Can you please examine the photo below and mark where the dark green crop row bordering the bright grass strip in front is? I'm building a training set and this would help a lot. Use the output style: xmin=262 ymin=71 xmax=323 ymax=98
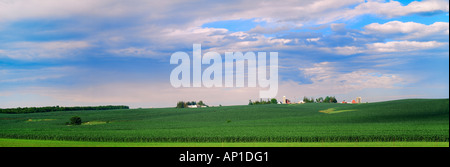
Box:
xmin=0 ymin=134 xmax=449 ymax=142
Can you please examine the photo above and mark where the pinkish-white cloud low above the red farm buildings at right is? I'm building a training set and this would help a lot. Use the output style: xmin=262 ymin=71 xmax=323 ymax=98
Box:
xmin=290 ymin=62 xmax=407 ymax=96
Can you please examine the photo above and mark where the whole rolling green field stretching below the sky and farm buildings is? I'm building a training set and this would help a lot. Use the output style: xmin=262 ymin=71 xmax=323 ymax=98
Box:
xmin=0 ymin=99 xmax=449 ymax=147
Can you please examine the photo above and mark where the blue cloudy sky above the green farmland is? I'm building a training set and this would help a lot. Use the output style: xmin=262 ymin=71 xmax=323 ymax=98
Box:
xmin=0 ymin=0 xmax=449 ymax=108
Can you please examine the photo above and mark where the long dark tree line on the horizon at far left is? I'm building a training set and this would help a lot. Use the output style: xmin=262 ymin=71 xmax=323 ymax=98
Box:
xmin=0 ymin=105 xmax=130 ymax=114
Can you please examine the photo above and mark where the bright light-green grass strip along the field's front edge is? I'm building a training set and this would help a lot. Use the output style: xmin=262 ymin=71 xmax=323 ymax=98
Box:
xmin=0 ymin=139 xmax=449 ymax=147
